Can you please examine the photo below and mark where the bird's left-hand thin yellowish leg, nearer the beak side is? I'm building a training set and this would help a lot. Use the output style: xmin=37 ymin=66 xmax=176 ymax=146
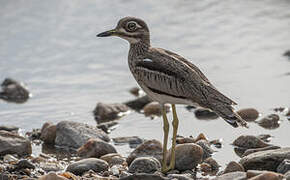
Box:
xmin=161 ymin=104 xmax=169 ymax=172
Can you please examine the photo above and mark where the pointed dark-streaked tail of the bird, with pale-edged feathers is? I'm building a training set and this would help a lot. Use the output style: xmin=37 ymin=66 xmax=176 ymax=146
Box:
xmin=212 ymin=105 xmax=249 ymax=128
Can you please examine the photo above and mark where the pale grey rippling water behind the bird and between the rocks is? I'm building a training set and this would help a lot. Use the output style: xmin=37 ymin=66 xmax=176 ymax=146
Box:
xmin=0 ymin=0 xmax=290 ymax=169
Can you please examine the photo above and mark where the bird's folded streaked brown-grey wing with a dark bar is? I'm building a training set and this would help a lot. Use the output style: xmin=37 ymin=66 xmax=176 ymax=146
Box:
xmin=135 ymin=48 xmax=234 ymax=105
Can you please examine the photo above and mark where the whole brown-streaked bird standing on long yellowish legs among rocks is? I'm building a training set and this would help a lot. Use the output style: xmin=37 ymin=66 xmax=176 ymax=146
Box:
xmin=97 ymin=16 xmax=248 ymax=172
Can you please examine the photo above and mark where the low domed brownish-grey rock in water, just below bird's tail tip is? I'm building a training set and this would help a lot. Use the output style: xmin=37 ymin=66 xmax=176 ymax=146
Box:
xmin=233 ymin=135 xmax=269 ymax=149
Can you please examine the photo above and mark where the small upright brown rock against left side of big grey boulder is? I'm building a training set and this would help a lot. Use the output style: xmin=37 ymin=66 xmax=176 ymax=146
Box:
xmin=40 ymin=122 xmax=56 ymax=144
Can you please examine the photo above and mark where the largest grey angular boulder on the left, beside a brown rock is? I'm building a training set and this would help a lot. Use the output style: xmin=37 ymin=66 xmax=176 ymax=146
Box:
xmin=55 ymin=121 xmax=110 ymax=149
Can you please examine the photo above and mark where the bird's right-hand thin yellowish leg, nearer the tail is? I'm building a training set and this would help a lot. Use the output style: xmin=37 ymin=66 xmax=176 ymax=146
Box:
xmin=169 ymin=104 xmax=179 ymax=169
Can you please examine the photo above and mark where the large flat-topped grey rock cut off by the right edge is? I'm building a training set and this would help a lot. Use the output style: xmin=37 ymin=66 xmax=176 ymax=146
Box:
xmin=240 ymin=147 xmax=290 ymax=171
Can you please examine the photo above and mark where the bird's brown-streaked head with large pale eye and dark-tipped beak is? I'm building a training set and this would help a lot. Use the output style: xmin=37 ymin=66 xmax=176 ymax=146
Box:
xmin=97 ymin=17 xmax=150 ymax=45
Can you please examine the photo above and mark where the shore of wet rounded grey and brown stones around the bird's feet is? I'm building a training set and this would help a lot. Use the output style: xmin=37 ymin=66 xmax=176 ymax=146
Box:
xmin=0 ymin=84 xmax=290 ymax=180
